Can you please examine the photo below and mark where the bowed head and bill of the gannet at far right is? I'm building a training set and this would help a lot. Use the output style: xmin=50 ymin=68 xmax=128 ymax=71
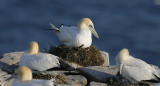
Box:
xmin=116 ymin=48 xmax=129 ymax=74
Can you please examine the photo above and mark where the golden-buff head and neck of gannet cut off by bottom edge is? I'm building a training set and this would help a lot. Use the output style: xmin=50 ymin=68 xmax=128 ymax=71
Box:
xmin=15 ymin=66 xmax=32 ymax=81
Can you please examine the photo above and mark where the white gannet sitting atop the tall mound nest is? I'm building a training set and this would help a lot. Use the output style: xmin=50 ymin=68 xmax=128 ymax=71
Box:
xmin=50 ymin=18 xmax=99 ymax=48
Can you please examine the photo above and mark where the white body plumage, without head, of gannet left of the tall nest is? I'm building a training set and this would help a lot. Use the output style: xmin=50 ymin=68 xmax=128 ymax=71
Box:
xmin=19 ymin=53 xmax=59 ymax=71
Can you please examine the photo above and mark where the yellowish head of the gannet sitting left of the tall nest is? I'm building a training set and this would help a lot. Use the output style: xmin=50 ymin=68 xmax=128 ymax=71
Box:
xmin=28 ymin=41 xmax=39 ymax=55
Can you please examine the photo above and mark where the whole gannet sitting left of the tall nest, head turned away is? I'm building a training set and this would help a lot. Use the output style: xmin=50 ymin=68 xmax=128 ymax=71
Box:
xmin=19 ymin=42 xmax=59 ymax=71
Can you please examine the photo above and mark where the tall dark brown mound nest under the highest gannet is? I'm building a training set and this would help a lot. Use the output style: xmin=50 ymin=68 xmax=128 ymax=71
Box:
xmin=49 ymin=45 xmax=104 ymax=67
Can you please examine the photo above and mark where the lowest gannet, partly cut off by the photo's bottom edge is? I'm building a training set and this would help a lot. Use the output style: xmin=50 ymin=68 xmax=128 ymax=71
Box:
xmin=9 ymin=66 xmax=54 ymax=86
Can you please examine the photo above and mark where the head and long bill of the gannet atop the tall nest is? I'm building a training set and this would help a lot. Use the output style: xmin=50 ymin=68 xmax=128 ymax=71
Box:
xmin=77 ymin=18 xmax=99 ymax=39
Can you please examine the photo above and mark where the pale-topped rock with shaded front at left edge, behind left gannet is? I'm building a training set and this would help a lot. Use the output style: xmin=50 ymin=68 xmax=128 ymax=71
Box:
xmin=0 ymin=52 xmax=23 ymax=73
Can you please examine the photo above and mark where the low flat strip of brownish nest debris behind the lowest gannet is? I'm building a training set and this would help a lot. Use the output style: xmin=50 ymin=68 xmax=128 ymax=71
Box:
xmin=33 ymin=73 xmax=67 ymax=84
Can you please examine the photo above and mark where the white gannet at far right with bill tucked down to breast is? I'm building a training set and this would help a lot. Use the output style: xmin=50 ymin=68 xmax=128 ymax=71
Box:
xmin=115 ymin=49 xmax=160 ymax=83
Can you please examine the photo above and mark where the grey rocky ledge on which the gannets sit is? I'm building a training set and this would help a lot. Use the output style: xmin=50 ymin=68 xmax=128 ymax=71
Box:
xmin=0 ymin=51 xmax=157 ymax=86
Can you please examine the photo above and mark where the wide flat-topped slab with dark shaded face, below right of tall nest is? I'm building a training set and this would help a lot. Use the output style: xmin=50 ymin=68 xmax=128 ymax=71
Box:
xmin=78 ymin=66 xmax=118 ymax=82
